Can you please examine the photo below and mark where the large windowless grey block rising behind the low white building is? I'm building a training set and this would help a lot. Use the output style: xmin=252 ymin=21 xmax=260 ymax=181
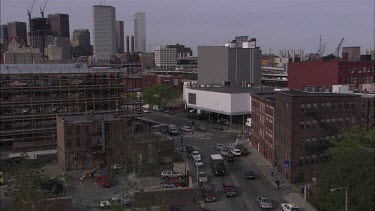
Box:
xmin=198 ymin=46 xmax=262 ymax=86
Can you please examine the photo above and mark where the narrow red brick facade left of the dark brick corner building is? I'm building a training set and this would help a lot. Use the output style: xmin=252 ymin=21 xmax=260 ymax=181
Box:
xmin=251 ymin=93 xmax=275 ymax=163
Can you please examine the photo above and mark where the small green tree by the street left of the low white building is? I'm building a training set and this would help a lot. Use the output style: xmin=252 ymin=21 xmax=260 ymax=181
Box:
xmin=142 ymin=85 xmax=180 ymax=108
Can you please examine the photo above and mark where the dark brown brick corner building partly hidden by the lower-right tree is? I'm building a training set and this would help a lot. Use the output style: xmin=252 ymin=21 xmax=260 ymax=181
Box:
xmin=274 ymin=91 xmax=361 ymax=183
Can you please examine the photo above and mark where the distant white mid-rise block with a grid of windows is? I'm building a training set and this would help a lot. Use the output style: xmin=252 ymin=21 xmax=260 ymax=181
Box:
xmin=154 ymin=46 xmax=177 ymax=69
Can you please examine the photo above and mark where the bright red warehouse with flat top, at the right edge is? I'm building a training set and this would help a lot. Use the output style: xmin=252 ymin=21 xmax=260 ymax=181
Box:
xmin=288 ymin=61 xmax=375 ymax=90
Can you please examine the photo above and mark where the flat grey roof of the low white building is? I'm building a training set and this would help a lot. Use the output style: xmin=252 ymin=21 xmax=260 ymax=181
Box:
xmin=189 ymin=86 xmax=273 ymax=94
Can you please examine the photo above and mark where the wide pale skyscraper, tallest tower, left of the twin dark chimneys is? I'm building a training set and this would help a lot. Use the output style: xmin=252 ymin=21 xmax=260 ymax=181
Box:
xmin=92 ymin=5 xmax=116 ymax=60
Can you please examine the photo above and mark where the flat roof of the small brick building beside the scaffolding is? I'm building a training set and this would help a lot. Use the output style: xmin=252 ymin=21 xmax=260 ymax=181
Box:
xmin=61 ymin=113 xmax=120 ymax=124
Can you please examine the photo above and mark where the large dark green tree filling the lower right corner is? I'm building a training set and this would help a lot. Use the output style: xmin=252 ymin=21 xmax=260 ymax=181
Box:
xmin=313 ymin=128 xmax=375 ymax=211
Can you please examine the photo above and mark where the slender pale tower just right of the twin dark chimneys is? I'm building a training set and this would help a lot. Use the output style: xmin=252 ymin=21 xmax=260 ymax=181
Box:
xmin=134 ymin=12 xmax=146 ymax=53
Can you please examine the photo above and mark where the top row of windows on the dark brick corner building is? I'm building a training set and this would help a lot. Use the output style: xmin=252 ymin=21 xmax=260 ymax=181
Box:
xmin=300 ymin=101 xmax=357 ymax=112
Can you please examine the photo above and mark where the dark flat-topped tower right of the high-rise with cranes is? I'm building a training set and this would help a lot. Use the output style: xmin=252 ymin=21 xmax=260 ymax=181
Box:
xmin=48 ymin=13 xmax=70 ymax=38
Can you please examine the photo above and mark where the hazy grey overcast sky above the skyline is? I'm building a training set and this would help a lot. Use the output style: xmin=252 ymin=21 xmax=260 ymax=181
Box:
xmin=0 ymin=0 xmax=375 ymax=54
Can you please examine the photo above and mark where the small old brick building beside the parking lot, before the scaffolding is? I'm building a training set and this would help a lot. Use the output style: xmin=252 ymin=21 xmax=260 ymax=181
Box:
xmin=56 ymin=113 xmax=122 ymax=171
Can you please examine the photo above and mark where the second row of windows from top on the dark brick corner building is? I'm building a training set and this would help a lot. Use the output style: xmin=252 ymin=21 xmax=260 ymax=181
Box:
xmin=300 ymin=117 xmax=356 ymax=129
